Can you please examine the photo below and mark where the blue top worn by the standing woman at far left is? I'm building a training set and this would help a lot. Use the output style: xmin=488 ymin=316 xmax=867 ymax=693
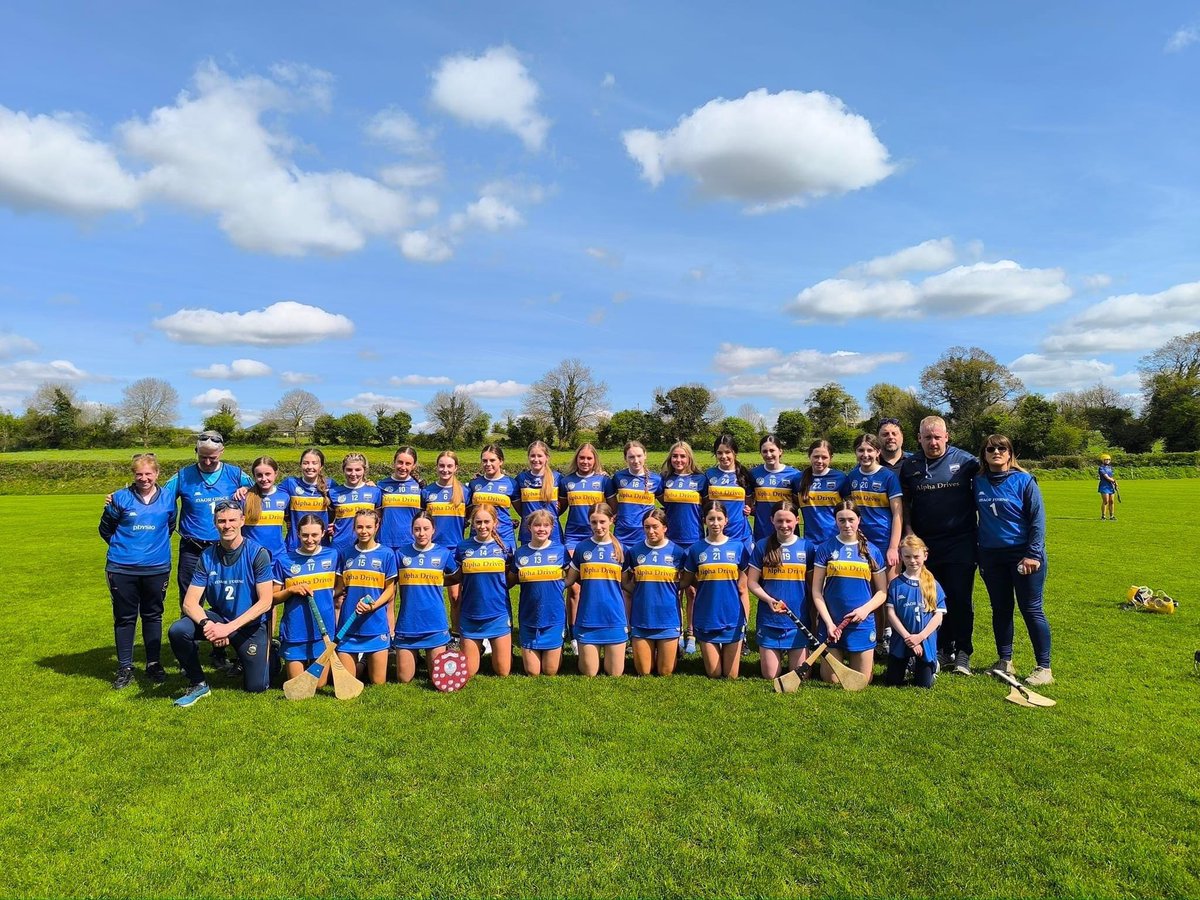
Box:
xmin=100 ymin=487 xmax=175 ymax=575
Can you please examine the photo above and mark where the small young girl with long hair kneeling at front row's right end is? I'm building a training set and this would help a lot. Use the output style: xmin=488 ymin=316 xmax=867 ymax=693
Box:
xmin=883 ymin=534 xmax=946 ymax=688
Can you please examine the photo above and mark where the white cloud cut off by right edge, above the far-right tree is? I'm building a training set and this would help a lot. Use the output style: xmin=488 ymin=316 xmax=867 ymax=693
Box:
xmin=1042 ymin=281 xmax=1200 ymax=355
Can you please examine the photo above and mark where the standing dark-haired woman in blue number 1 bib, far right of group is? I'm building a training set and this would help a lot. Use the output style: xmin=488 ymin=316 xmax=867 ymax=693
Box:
xmin=974 ymin=434 xmax=1054 ymax=685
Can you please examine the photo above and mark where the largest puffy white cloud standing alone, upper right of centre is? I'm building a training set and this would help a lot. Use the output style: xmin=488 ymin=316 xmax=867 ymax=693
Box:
xmin=622 ymin=89 xmax=893 ymax=212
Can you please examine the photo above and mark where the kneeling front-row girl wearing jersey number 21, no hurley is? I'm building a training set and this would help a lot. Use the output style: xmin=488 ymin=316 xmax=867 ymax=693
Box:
xmin=682 ymin=500 xmax=750 ymax=678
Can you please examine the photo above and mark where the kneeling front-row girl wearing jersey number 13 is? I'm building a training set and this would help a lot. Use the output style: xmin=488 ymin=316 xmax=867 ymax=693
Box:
xmin=509 ymin=509 xmax=568 ymax=676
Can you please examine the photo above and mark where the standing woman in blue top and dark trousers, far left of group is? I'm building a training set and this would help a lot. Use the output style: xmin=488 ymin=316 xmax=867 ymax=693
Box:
xmin=100 ymin=454 xmax=175 ymax=690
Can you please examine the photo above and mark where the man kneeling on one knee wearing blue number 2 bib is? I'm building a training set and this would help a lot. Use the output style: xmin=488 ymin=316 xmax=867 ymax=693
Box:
xmin=167 ymin=500 xmax=272 ymax=707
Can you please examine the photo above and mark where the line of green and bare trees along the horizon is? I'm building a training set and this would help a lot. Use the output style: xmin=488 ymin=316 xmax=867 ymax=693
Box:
xmin=0 ymin=331 xmax=1200 ymax=458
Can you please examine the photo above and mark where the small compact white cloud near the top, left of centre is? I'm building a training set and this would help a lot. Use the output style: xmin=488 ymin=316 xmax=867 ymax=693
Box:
xmin=431 ymin=46 xmax=550 ymax=150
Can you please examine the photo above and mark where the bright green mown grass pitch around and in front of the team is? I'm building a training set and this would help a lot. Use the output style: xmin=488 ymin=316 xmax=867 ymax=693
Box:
xmin=0 ymin=480 xmax=1200 ymax=896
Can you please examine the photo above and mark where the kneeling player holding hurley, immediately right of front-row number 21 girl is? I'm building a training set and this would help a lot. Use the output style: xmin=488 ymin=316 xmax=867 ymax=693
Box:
xmin=748 ymin=500 xmax=814 ymax=678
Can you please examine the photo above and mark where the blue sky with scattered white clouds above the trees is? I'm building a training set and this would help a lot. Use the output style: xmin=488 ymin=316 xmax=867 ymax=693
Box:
xmin=0 ymin=2 xmax=1200 ymax=434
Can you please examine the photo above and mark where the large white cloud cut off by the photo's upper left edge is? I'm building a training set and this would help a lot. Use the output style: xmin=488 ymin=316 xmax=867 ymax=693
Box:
xmin=0 ymin=106 xmax=142 ymax=216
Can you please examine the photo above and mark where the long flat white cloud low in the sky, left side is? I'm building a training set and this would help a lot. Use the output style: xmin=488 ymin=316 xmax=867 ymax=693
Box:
xmin=154 ymin=300 xmax=354 ymax=347
